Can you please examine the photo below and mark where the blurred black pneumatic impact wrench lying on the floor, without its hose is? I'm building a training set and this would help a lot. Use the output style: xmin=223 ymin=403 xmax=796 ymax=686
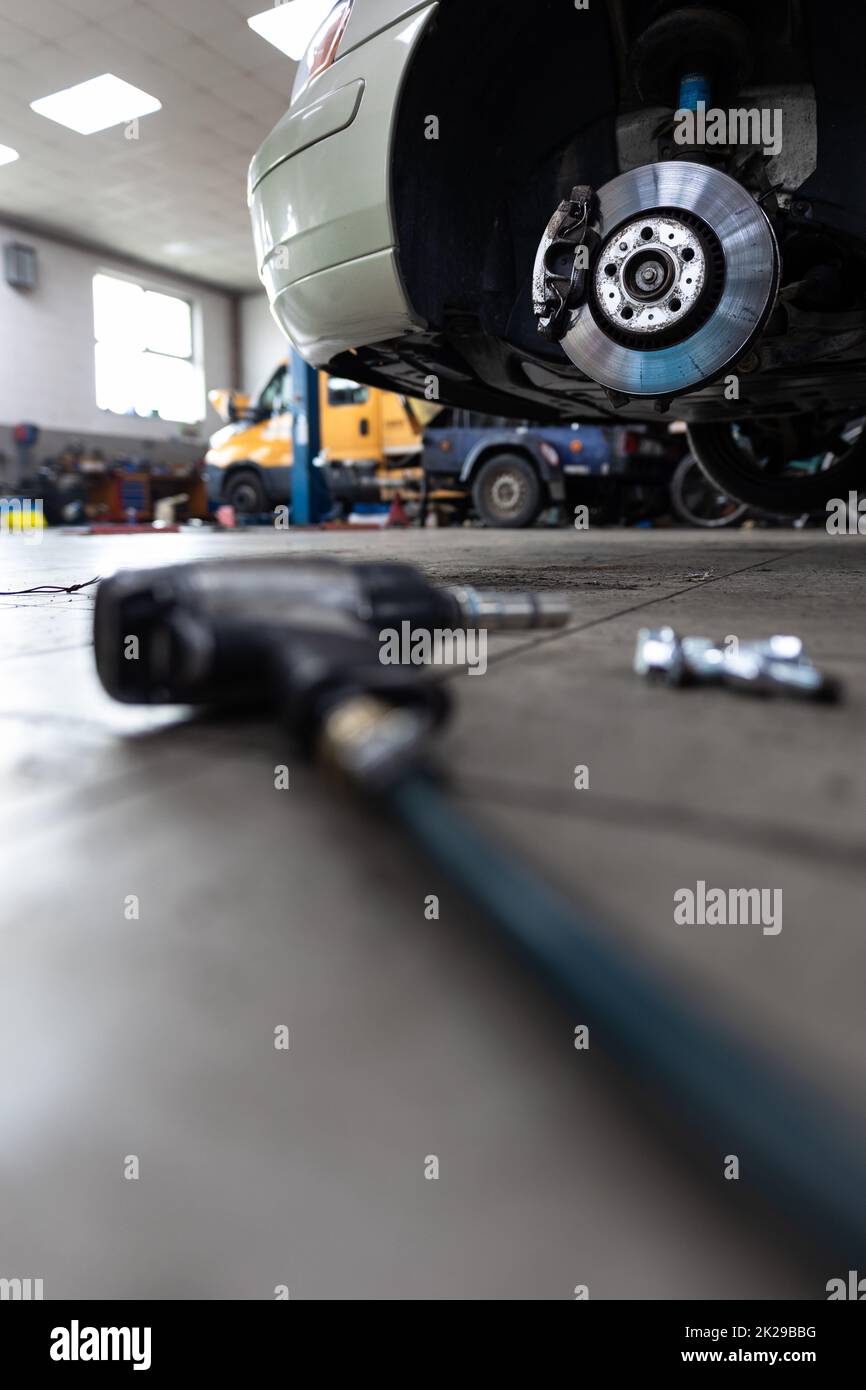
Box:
xmin=95 ymin=556 xmax=569 ymax=787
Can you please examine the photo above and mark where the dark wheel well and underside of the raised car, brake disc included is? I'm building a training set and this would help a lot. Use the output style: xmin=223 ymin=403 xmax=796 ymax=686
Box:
xmin=331 ymin=0 xmax=866 ymax=512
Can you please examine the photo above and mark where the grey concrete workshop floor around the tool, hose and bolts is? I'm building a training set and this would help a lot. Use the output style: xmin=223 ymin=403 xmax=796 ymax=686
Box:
xmin=0 ymin=530 xmax=866 ymax=1298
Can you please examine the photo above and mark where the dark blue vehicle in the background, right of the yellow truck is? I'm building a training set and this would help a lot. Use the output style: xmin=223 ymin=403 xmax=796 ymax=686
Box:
xmin=421 ymin=410 xmax=685 ymax=527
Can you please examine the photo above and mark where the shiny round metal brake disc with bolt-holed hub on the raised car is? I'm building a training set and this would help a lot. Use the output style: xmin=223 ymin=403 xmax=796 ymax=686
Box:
xmin=562 ymin=161 xmax=778 ymax=396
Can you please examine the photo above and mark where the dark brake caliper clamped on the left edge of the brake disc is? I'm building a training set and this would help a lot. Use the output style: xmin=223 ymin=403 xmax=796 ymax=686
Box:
xmin=532 ymin=183 xmax=598 ymax=342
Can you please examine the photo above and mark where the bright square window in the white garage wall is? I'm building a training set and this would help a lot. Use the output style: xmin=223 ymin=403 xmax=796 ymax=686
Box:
xmin=93 ymin=274 xmax=204 ymax=424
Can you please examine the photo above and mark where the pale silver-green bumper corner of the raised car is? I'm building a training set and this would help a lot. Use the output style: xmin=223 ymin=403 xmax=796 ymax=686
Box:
xmin=249 ymin=0 xmax=436 ymax=366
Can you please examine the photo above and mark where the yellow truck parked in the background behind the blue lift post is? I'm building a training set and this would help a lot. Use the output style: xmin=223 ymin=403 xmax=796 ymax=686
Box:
xmin=204 ymin=361 xmax=423 ymax=516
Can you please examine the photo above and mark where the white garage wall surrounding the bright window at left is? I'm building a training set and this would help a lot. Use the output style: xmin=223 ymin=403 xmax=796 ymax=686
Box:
xmin=0 ymin=222 xmax=235 ymax=441
